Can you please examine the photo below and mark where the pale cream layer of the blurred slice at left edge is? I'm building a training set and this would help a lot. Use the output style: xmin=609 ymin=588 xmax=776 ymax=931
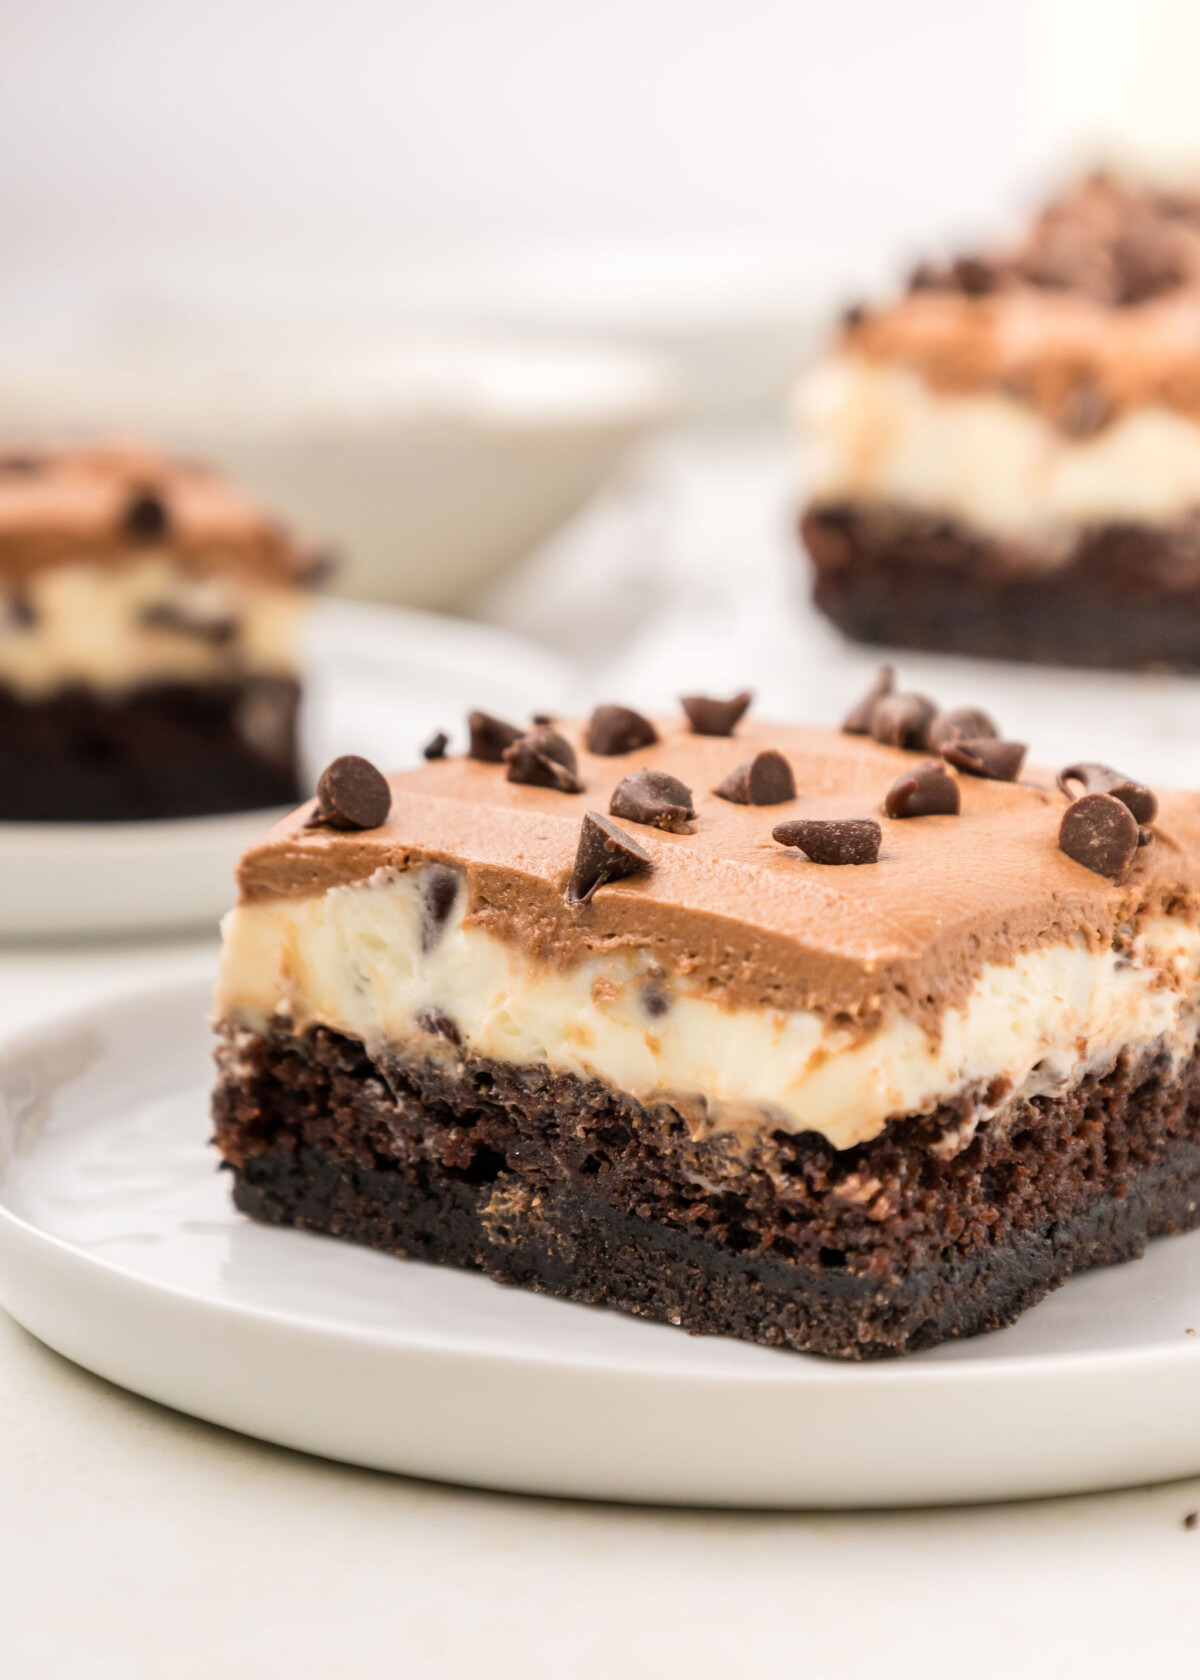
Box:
xmin=0 ymin=554 xmax=304 ymax=699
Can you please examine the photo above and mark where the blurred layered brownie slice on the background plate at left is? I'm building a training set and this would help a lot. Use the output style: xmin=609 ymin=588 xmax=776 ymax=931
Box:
xmin=0 ymin=445 xmax=316 ymax=822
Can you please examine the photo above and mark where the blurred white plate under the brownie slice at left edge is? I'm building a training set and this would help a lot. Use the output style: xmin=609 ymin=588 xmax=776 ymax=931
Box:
xmin=0 ymin=601 xmax=568 ymax=937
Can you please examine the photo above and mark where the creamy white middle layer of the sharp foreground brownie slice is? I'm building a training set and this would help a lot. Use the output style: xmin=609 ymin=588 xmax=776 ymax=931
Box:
xmin=217 ymin=870 xmax=1200 ymax=1149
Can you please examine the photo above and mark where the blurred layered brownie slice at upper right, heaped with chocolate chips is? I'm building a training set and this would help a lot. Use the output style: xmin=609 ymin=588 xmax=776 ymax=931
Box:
xmin=797 ymin=176 xmax=1200 ymax=669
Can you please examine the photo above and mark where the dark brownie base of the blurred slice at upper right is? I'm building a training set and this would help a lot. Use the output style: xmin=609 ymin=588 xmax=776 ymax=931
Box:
xmin=800 ymin=504 xmax=1200 ymax=670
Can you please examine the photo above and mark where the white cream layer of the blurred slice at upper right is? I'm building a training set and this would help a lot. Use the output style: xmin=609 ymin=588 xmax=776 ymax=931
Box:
xmin=795 ymin=356 xmax=1200 ymax=559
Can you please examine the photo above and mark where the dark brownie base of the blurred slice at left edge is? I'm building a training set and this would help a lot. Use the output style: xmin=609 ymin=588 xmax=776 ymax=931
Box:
xmin=0 ymin=679 xmax=303 ymax=823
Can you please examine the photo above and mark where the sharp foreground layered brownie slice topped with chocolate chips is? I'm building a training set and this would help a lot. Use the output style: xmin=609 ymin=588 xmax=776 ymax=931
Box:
xmin=215 ymin=688 xmax=1200 ymax=1359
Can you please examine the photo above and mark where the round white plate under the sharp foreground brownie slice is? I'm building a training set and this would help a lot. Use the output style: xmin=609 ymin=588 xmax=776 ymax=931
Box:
xmin=0 ymin=983 xmax=1200 ymax=1505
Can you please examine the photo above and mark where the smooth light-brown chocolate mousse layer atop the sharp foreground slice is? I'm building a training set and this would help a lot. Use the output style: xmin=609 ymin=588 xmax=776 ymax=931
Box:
xmin=231 ymin=716 xmax=1200 ymax=1032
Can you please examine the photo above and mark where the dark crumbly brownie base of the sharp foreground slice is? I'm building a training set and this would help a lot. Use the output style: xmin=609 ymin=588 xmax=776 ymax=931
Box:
xmin=213 ymin=1028 xmax=1200 ymax=1359
